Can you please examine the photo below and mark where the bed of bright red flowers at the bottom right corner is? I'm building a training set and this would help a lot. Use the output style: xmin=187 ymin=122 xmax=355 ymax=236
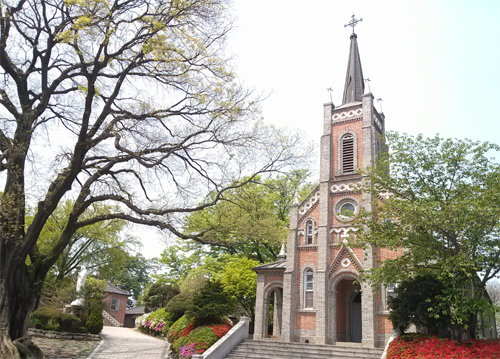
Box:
xmin=387 ymin=335 xmax=500 ymax=359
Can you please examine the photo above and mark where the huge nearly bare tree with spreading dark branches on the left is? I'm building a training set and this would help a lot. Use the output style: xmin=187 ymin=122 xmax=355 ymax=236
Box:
xmin=0 ymin=0 xmax=295 ymax=358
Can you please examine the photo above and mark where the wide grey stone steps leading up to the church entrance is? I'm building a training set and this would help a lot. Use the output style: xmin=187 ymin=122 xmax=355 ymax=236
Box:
xmin=226 ymin=339 xmax=384 ymax=359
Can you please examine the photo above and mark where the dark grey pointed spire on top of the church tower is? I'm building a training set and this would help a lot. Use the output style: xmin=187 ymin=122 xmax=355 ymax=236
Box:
xmin=342 ymin=33 xmax=365 ymax=105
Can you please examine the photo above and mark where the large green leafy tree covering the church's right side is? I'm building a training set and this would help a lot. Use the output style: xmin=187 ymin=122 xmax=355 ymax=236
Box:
xmin=358 ymin=133 xmax=500 ymax=339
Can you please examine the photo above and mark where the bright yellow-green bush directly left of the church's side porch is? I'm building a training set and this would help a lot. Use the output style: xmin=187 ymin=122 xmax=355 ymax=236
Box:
xmin=218 ymin=257 xmax=259 ymax=322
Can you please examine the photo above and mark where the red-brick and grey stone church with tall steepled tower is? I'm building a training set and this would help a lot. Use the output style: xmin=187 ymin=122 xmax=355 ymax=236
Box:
xmin=254 ymin=23 xmax=395 ymax=347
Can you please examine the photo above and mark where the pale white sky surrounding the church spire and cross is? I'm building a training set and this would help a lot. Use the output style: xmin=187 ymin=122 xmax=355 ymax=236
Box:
xmin=143 ymin=0 xmax=500 ymax=257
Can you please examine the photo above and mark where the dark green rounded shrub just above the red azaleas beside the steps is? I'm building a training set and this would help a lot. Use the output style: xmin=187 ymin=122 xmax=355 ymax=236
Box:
xmin=187 ymin=280 xmax=235 ymax=325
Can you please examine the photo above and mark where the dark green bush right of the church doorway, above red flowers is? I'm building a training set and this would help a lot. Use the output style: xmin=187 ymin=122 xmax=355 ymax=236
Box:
xmin=389 ymin=276 xmax=450 ymax=335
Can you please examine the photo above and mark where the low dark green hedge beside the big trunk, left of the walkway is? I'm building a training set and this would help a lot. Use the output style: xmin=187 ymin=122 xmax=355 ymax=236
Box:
xmin=29 ymin=307 xmax=85 ymax=333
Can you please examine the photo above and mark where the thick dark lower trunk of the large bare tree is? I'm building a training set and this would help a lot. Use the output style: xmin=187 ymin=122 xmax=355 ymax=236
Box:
xmin=0 ymin=248 xmax=43 ymax=359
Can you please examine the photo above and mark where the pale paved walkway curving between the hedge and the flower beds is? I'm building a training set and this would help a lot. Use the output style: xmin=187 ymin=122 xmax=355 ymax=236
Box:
xmin=89 ymin=326 xmax=168 ymax=359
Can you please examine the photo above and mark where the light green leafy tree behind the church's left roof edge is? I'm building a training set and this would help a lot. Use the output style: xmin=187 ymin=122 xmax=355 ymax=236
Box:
xmin=185 ymin=170 xmax=312 ymax=263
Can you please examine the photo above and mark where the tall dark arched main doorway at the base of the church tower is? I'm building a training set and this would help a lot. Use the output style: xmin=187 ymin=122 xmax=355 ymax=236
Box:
xmin=335 ymin=278 xmax=362 ymax=343
